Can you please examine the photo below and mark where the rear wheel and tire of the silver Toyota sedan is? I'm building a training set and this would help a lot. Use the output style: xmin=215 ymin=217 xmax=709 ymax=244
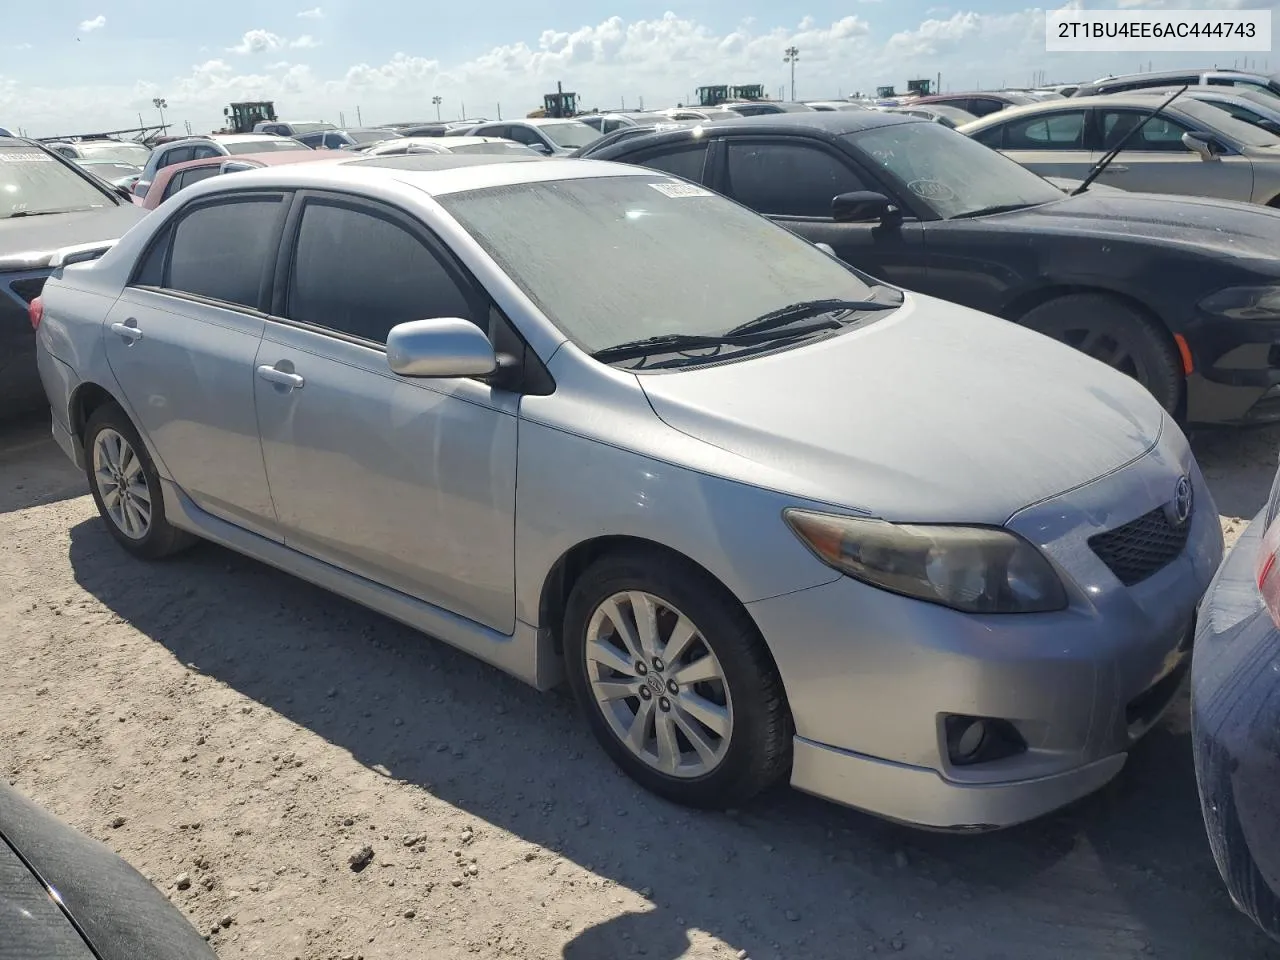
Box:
xmin=84 ymin=403 xmax=196 ymax=559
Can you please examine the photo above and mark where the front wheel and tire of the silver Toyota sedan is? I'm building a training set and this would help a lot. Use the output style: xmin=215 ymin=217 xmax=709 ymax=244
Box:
xmin=564 ymin=550 xmax=791 ymax=809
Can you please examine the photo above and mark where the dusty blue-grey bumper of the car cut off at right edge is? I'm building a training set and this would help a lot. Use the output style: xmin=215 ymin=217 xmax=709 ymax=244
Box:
xmin=1192 ymin=511 xmax=1280 ymax=940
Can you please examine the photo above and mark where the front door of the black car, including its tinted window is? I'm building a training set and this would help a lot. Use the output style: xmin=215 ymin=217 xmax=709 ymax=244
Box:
xmin=713 ymin=137 xmax=925 ymax=289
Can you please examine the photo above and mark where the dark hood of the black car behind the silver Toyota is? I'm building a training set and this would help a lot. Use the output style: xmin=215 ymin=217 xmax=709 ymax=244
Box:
xmin=984 ymin=187 xmax=1280 ymax=259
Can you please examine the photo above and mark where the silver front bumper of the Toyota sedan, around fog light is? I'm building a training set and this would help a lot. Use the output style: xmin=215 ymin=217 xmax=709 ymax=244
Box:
xmin=748 ymin=426 xmax=1222 ymax=829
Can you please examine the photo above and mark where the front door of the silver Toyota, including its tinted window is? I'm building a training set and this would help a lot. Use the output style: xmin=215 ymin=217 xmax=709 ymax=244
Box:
xmin=253 ymin=193 xmax=520 ymax=634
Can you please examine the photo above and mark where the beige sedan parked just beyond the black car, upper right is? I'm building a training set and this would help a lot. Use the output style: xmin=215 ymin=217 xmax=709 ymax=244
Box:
xmin=959 ymin=93 xmax=1280 ymax=206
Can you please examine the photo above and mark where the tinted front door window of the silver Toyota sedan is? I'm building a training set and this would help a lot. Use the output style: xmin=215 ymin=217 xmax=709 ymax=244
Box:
xmin=287 ymin=201 xmax=471 ymax=343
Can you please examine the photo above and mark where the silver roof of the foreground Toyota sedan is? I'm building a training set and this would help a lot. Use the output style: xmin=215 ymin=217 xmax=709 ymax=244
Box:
xmin=183 ymin=154 xmax=667 ymax=204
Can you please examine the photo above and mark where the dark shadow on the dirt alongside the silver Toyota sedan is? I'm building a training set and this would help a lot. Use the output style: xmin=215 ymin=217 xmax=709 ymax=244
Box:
xmin=70 ymin=520 xmax=1271 ymax=960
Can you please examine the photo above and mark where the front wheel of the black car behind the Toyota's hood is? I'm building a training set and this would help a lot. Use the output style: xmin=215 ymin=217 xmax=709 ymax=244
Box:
xmin=1018 ymin=293 xmax=1184 ymax=413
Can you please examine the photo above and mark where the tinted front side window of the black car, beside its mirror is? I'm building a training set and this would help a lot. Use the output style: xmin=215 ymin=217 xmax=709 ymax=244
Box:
xmin=727 ymin=140 xmax=865 ymax=216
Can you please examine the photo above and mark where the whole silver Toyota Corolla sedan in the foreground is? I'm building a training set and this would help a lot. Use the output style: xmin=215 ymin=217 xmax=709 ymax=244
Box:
xmin=32 ymin=155 xmax=1222 ymax=829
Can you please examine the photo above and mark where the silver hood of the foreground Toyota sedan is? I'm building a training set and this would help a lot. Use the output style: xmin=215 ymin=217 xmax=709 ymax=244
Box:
xmin=637 ymin=294 xmax=1165 ymax=524
